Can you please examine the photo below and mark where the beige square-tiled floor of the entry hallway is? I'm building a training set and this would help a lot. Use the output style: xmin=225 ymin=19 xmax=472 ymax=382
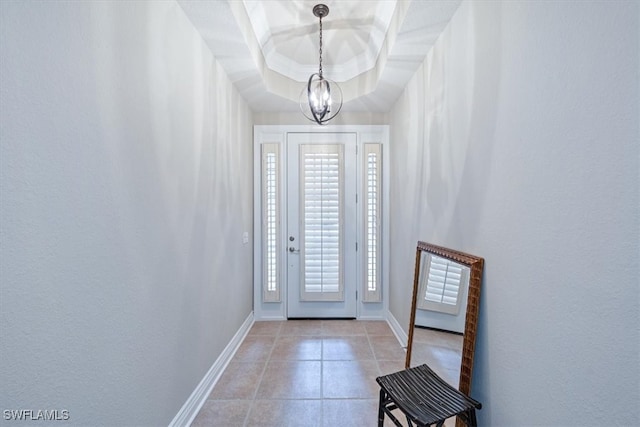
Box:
xmin=192 ymin=320 xmax=459 ymax=427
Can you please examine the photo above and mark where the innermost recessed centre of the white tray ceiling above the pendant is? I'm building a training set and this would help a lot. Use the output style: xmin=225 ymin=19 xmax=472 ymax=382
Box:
xmin=243 ymin=0 xmax=396 ymax=83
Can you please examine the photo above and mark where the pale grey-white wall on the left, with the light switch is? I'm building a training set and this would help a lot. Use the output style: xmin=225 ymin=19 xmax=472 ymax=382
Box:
xmin=0 ymin=1 xmax=253 ymax=426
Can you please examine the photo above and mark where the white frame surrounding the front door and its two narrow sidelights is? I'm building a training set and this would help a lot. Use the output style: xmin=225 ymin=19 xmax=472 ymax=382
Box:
xmin=253 ymin=125 xmax=390 ymax=320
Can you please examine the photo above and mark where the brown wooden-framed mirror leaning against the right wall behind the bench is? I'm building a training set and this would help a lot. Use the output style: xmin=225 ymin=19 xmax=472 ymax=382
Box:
xmin=405 ymin=242 xmax=484 ymax=395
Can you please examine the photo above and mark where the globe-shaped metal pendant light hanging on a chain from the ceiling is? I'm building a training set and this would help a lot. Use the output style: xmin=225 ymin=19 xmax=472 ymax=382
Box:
xmin=300 ymin=4 xmax=342 ymax=125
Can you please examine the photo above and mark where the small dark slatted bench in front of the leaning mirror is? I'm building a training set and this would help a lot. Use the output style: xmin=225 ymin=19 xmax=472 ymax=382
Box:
xmin=376 ymin=365 xmax=482 ymax=427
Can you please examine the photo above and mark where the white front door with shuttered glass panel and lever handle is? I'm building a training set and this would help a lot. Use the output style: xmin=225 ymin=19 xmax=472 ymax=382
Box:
xmin=286 ymin=133 xmax=358 ymax=318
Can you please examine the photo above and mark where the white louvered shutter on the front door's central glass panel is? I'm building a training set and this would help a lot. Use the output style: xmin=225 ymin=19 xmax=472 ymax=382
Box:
xmin=299 ymin=144 xmax=344 ymax=301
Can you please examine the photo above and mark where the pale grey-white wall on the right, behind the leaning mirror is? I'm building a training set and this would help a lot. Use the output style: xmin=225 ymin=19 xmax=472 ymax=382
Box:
xmin=390 ymin=1 xmax=640 ymax=426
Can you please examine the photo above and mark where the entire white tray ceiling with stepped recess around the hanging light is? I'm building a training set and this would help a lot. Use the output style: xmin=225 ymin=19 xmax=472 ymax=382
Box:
xmin=178 ymin=0 xmax=461 ymax=112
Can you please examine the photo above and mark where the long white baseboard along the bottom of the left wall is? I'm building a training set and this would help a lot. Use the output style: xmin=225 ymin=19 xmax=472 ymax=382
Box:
xmin=169 ymin=312 xmax=254 ymax=427
